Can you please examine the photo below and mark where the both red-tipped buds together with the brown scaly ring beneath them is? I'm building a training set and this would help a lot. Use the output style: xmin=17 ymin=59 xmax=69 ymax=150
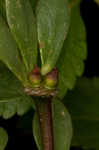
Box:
xmin=25 ymin=65 xmax=58 ymax=96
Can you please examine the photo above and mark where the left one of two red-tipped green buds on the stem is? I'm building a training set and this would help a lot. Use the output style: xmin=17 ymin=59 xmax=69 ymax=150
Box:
xmin=28 ymin=65 xmax=41 ymax=87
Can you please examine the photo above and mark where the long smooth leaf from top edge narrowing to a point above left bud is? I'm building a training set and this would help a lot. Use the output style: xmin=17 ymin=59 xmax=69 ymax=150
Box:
xmin=6 ymin=0 xmax=37 ymax=72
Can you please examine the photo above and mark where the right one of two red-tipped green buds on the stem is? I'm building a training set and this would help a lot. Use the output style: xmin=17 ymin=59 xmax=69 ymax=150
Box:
xmin=44 ymin=68 xmax=58 ymax=89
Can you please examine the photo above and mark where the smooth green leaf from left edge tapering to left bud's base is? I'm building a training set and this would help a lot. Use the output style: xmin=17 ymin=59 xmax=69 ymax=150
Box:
xmin=0 ymin=16 xmax=27 ymax=84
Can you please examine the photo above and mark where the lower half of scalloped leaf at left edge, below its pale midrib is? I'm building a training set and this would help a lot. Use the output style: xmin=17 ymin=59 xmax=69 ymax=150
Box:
xmin=0 ymin=96 xmax=35 ymax=119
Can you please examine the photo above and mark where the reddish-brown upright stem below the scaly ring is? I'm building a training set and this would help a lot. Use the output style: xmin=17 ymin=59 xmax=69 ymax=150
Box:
xmin=37 ymin=98 xmax=54 ymax=150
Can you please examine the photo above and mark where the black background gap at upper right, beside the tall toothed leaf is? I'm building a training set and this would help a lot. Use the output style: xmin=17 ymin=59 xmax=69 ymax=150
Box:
xmin=81 ymin=0 xmax=99 ymax=77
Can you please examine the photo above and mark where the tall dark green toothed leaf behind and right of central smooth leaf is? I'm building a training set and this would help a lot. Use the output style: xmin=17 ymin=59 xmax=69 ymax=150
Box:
xmin=57 ymin=5 xmax=86 ymax=99
